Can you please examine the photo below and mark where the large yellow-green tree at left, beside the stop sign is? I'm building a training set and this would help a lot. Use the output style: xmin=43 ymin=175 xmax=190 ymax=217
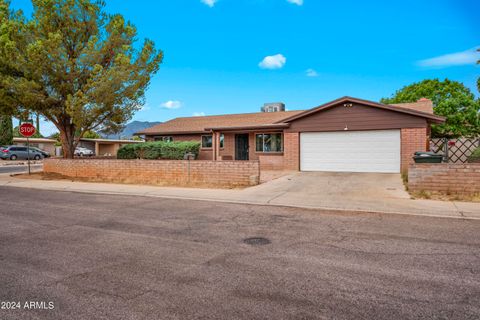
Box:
xmin=0 ymin=0 xmax=163 ymax=158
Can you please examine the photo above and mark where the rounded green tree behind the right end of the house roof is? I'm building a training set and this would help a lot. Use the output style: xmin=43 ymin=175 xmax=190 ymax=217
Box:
xmin=381 ymin=79 xmax=480 ymax=138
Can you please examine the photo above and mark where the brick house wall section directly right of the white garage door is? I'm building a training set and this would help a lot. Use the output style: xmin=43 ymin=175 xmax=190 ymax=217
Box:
xmin=401 ymin=128 xmax=428 ymax=173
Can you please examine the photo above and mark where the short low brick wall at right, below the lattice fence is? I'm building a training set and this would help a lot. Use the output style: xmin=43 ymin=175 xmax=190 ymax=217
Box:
xmin=408 ymin=163 xmax=480 ymax=195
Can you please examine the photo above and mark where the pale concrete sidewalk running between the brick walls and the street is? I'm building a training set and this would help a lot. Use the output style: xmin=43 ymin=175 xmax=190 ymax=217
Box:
xmin=0 ymin=174 xmax=480 ymax=220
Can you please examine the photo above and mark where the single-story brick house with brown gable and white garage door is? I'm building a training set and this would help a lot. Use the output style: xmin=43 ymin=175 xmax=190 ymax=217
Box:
xmin=137 ymin=97 xmax=445 ymax=173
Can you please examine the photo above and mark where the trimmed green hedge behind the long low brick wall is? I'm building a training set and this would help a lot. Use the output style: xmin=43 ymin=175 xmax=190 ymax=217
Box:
xmin=117 ymin=141 xmax=200 ymax=160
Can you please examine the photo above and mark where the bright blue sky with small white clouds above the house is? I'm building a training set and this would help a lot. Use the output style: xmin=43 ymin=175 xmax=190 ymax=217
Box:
xmin=12 ymin=0 xmax=480 ymax=134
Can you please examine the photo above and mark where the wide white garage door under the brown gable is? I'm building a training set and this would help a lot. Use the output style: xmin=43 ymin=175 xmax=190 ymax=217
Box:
xmin=300 ymin=130 xmax=400 ymax=173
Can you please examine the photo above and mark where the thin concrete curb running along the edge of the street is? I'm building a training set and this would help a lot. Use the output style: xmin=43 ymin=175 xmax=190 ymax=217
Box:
xmin=0 ymin=181 xmax=480 ymax=220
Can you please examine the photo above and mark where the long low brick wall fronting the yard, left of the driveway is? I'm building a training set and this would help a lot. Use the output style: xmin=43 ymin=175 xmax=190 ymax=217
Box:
xmin=43 ymin=159 xmax=260 ymax=188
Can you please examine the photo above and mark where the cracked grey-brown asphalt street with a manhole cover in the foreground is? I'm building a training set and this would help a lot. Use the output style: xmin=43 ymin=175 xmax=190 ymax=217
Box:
xmin=0 ymin=187 xmax=480 ymax=320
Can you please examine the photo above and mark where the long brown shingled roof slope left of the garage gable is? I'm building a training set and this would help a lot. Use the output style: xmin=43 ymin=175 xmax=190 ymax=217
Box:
xmin=136 ymin=110 xmax=303 ymax=135
